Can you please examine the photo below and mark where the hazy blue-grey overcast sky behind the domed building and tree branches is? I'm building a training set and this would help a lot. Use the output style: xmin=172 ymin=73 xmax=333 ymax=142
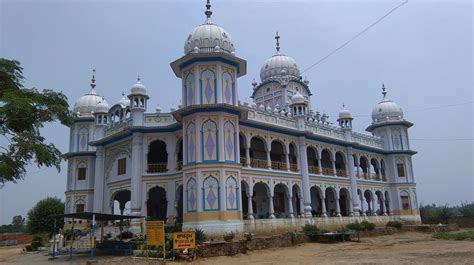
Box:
xmin=0 ymin=0 xmax=474 ymax=223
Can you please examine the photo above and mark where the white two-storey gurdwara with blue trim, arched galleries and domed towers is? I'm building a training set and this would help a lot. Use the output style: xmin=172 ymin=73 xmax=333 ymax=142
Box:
xmin=65 ymin=2 xmax=420 ymax=233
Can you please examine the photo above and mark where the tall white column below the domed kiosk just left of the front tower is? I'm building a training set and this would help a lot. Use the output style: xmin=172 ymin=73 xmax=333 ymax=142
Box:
xmin=130 ymin=133 xmax=143 ymax=215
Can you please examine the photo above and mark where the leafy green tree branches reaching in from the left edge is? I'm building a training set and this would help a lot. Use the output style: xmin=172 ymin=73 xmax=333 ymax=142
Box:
xmin=0 ymin=58 xmax=73 ymax=183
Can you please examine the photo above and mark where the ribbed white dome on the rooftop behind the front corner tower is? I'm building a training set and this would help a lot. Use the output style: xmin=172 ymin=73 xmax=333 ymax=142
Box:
xmin=260 ymin=53 xmax=300 ymax=82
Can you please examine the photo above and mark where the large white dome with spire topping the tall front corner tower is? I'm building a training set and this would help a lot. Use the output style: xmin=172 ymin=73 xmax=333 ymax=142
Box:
xmin=184 ymin=2 xmax=235 ymax=54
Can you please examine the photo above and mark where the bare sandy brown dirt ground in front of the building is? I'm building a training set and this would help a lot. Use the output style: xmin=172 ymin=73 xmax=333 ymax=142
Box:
xmin=0 ymin=232 xmax=474 ymax=265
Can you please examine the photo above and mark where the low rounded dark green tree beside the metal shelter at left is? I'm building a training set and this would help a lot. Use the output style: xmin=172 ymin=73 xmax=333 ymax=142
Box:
xmin=27 ymin=197 xmax=64 ymax=234
